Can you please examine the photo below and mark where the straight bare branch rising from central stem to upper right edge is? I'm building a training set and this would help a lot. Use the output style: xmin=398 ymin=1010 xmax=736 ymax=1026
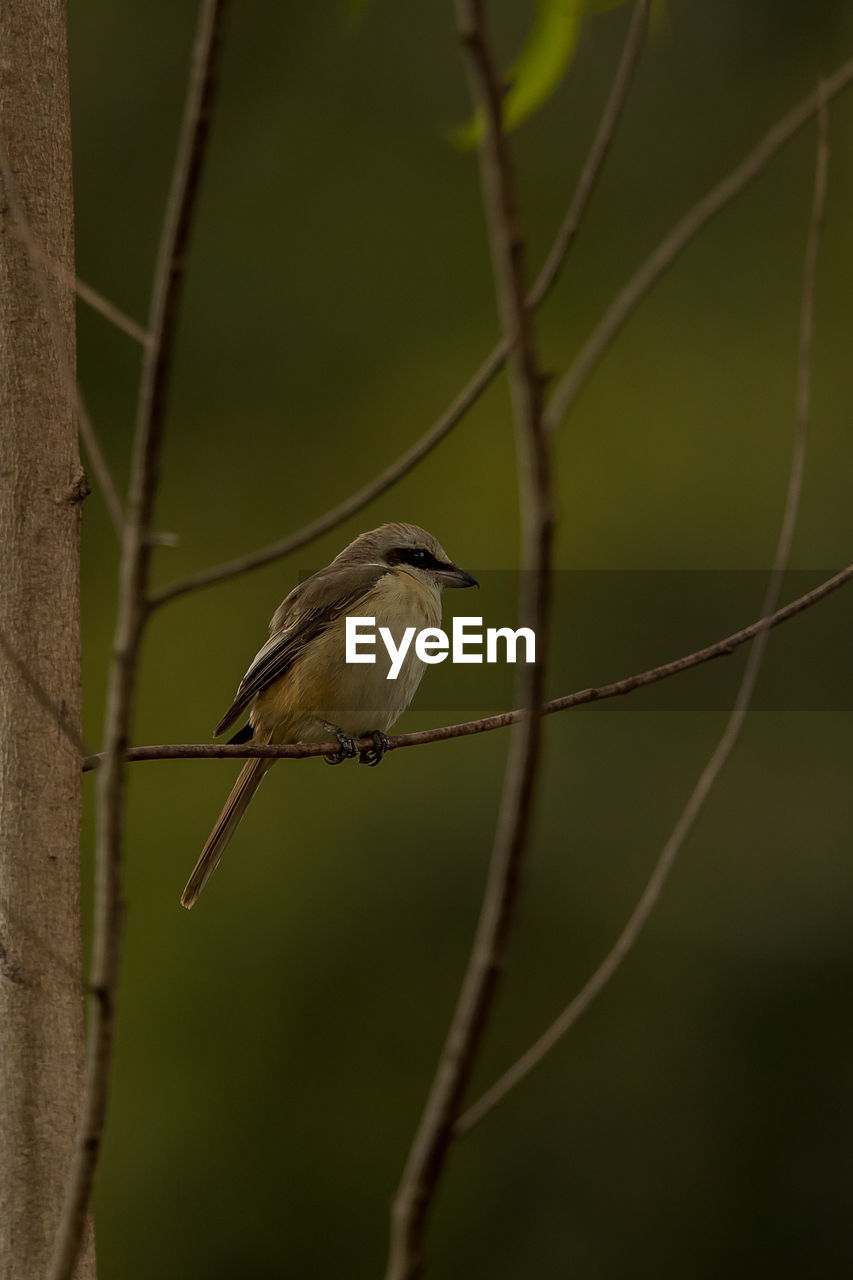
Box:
xmin=546 ymin=58 xmax=853 ymax=431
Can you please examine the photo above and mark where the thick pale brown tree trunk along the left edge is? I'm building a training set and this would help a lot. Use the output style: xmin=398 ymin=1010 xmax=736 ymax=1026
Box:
xmin=0 ymin=0 xmax=95 ymax=1280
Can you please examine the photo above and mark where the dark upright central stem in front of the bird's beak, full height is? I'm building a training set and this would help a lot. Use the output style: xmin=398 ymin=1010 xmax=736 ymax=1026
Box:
xmin=386 ymin=0 xmax=553 ymax=1280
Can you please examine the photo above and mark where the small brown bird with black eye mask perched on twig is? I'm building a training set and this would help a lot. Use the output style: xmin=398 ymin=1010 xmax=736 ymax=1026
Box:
xmin=181 ymin=524 xmax=478 ymax=908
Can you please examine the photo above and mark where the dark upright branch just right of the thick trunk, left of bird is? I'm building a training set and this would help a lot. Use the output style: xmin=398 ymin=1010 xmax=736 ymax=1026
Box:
xmin=50 ymin=0 xmax=225 ymax=1280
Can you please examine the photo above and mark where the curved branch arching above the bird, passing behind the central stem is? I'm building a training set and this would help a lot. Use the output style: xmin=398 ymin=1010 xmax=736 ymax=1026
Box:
xmin=151 ymin=0 xmax=649 ymax=607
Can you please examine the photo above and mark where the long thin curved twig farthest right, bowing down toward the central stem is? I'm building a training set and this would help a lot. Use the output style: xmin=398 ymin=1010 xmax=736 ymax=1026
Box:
xmin=456 ymin=99 xmax=829 ymax=1134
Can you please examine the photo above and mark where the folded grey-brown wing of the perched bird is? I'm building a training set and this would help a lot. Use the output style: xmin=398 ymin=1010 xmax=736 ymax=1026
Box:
xmin=214 ymin=564 xmax=388 ymax=737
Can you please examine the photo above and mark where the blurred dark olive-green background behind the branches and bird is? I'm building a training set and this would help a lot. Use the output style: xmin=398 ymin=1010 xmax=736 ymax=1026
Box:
xmin=69 ymin=0 xmax=853 ymax=1280
